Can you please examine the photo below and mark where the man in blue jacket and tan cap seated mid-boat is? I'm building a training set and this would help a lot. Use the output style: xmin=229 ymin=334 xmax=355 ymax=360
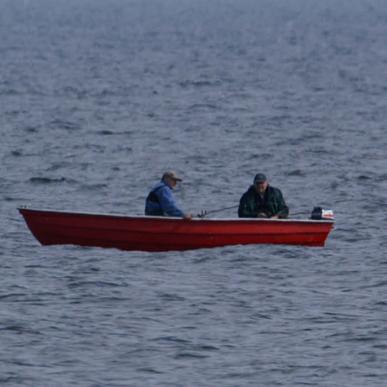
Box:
xmin=145 ymin=171 xmax=192 ymax=219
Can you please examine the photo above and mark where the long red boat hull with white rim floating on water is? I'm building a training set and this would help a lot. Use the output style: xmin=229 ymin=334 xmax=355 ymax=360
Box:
xmin=19 ymin=208 xmax=333 ymax=251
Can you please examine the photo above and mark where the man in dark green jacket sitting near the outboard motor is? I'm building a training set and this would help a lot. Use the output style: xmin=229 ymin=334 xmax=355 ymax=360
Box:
xmin=238 ymin=173 xmax=289 ymax=219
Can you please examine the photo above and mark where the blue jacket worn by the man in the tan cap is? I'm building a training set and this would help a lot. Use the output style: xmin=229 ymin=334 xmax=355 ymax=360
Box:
xmin=145 ymin=180 xmax=184 ymax=217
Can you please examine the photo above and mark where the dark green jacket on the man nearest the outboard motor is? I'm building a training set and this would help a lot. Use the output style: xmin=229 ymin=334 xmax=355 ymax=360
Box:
xmin=238 ymin=185 xmax=289 ymax=218
